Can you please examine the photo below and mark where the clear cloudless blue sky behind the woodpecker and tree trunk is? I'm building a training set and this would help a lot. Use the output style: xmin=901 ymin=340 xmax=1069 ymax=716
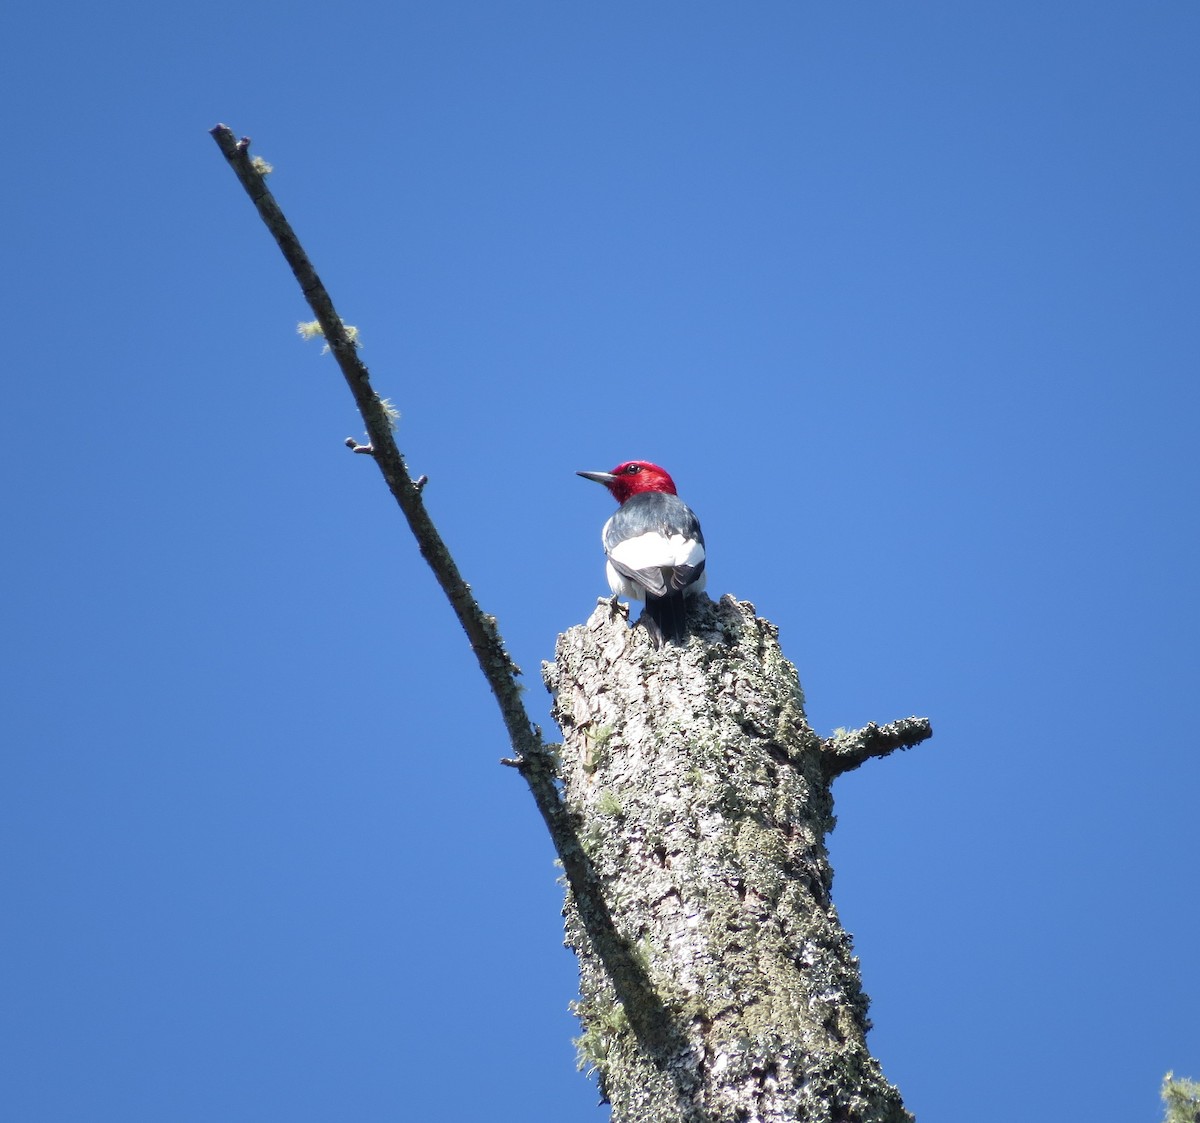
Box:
xmin=0 ymin=0 xmax=1200 ymax=1123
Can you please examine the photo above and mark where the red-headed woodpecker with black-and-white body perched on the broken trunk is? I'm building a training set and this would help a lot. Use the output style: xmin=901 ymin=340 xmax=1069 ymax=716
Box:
xmin=576 ymin=461 xmax=708 ymax=644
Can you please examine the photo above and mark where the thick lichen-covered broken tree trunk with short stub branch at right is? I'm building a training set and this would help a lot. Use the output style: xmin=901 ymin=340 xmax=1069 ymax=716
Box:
xmin=545 ymin=597 xmax=929 ymax=1123
